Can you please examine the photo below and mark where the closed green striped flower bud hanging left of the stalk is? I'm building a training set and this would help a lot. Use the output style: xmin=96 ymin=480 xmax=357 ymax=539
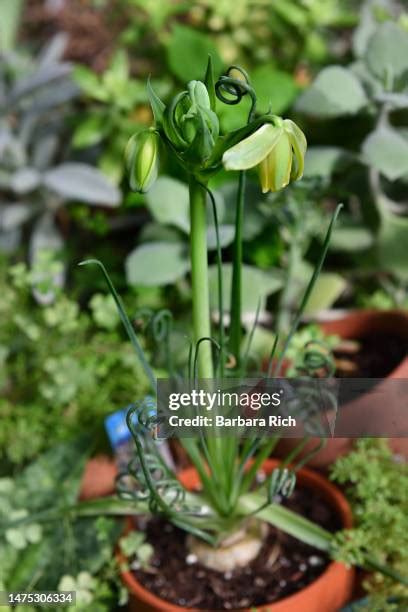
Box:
xmin=125 ymin=129 xmax=159 ymax=193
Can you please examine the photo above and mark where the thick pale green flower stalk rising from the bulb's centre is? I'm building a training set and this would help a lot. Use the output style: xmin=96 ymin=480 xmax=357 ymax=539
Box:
xmin=190 ymin=177 xmax=213 ymax=378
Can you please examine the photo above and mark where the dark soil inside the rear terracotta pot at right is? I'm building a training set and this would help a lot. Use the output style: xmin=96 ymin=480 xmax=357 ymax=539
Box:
xmin=334 ymin=333 xmax=408 ymax=378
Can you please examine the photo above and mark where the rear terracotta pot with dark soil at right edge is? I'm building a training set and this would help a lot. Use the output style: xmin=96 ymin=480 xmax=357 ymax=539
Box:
xmin=277 ymin=309 xmax=408 ymax=469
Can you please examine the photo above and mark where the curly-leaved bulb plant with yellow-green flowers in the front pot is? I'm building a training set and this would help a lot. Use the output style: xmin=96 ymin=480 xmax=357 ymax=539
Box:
xmin=84 ymin=60 xmax=338 ymax=566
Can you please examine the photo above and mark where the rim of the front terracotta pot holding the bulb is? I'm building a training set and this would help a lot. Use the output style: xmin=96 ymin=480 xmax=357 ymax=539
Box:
xmin=117 ymin=458 xmax=354 ymax=612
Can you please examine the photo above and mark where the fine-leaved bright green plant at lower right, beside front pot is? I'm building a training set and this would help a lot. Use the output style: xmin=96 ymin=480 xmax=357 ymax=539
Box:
xmin=331 ymin=439 xmax=408 ymax=611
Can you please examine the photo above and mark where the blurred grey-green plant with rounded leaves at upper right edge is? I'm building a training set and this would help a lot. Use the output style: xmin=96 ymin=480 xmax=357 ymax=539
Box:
xmin=297 ymin=0 xmax=408 ymax=280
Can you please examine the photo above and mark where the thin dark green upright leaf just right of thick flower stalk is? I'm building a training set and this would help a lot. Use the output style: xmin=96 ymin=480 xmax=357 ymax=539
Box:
xmin=230 ymin=171 xmax=246 ymax=370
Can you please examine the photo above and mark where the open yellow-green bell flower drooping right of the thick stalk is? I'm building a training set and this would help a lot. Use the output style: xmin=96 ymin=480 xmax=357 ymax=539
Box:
xmin=222 ymin=117 xmax=307 ymax=193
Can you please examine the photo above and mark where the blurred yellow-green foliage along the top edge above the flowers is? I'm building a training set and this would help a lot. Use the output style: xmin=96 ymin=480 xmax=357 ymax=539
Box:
xmin=118 ymin=0 xmax=357 ymax=74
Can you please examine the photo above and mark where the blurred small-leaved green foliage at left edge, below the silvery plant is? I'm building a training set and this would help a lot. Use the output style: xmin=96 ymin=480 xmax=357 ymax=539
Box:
xmin=0 ymin=261 xmax=145 ymax=466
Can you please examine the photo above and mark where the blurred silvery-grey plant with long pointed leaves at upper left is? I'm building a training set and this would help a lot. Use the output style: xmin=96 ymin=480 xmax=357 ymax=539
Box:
xmin=0 ymin=35 xmax=121 ymax=262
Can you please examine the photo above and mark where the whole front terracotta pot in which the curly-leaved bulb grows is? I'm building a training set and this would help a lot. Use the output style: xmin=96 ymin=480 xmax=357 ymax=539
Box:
xmin=118 ymin=459 xmax=355 ymax=612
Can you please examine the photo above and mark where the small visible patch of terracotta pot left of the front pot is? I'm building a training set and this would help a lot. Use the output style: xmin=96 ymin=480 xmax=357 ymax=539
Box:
xmin=79 ymin=455 xmax=117 ymax=500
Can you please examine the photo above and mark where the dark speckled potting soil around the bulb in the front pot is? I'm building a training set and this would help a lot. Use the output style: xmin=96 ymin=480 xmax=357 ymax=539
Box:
xmin=134 ymin=489 xmax=341 ymax=610
